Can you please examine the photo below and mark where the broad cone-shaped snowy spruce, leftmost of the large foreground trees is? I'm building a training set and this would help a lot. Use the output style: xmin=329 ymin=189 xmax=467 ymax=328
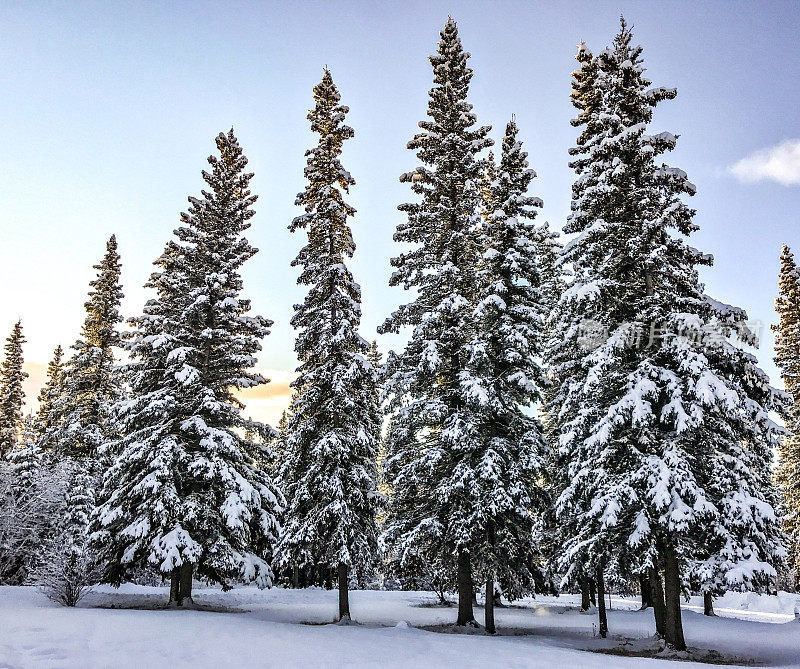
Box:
xmin=91 ymin=130 xmax=281 ymax=605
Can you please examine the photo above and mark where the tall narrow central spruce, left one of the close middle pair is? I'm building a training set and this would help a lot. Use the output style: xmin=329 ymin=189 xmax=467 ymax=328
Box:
xmin=382 ymin=19 xmax=493 ymax=625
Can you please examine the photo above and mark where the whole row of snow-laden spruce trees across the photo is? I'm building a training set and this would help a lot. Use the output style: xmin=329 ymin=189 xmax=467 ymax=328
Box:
xmin=0 ymin=19 xmax=800 ymax=650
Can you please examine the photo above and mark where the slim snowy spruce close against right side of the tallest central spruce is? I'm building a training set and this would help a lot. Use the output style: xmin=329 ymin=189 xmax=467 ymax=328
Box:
xmin=467 ymin=121 xmax=549 ymax=633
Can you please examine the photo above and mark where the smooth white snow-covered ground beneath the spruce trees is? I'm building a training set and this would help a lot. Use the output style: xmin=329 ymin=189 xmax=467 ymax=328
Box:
xmin=0 ymin=585 xmax=800 ymax=669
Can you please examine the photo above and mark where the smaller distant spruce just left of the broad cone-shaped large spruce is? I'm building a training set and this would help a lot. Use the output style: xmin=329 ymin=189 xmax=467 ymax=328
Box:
xmin=43 ymin=235 xmax=122 ymax=458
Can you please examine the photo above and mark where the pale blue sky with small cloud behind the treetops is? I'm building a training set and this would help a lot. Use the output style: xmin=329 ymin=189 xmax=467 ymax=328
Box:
xmin=0 ymin=0 xmax=800 ymax=420
